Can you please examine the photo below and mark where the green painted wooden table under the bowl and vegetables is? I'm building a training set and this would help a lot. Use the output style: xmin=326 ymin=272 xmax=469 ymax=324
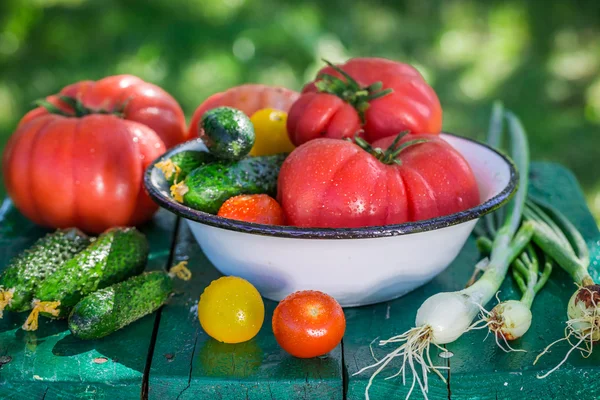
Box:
xmin=0 ymin=163 xmax=600 ymax=400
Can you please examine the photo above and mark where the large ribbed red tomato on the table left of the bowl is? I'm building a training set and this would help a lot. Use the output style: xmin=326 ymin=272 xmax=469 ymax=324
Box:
xmin=2 ymin=75 xmax=188 ymax=233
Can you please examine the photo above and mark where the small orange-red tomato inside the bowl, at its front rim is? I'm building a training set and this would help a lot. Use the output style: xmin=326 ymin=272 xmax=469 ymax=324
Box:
xmin=217 ymin=194 xmax=283 ymax=225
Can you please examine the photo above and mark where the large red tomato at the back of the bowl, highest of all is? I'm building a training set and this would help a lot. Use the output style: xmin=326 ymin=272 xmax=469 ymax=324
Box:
xmin=287 ymin=58 xmax=442 ymax=146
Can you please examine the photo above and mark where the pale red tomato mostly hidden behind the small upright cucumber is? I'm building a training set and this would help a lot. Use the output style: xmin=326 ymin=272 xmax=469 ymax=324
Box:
xmin=189 ymin=83 xmax=300 ymax=137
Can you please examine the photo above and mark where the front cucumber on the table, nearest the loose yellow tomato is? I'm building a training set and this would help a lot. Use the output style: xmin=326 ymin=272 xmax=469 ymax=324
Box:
xmin=69 ymin=271 xmax=173 ymax=339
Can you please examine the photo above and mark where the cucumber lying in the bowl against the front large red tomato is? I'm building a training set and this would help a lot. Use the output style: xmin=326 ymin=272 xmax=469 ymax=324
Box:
xmin=183 ymin=154 xmax=287 ymax=214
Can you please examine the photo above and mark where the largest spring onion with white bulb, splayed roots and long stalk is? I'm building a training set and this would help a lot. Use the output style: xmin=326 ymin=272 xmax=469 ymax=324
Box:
xmin=356 ymin=107 xmax=534 ymax=400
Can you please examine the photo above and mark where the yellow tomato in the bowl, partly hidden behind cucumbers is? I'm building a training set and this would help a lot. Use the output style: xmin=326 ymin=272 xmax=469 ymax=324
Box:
xmin=250 ymin=108 xmax=294 ymax=156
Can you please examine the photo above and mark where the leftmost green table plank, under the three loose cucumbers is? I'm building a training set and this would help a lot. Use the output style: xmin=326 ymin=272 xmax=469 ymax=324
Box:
xmin=0 ymin=202 xmax=175 ymax=400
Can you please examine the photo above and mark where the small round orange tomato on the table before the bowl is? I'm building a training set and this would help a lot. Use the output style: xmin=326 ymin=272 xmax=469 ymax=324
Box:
xmin=272 ymin=290 xmax=346 ymax=358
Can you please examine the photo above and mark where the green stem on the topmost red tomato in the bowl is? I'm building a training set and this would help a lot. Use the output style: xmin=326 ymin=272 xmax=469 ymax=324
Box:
xmin=315 ymin=59 xmax=393 ymax=124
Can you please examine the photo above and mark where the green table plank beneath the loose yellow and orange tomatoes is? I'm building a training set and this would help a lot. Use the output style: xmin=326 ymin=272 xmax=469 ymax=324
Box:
xmin=149 ymin=224 xmax=343 ymax=400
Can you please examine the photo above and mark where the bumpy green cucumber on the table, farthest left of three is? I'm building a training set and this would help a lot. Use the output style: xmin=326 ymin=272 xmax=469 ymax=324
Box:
xmin=0 ymin=228 xmax=90 ymax=312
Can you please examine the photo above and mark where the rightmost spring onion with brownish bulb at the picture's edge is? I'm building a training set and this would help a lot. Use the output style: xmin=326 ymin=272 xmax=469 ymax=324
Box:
xmin=524 ymin=202 xmax=600 ymax=378
